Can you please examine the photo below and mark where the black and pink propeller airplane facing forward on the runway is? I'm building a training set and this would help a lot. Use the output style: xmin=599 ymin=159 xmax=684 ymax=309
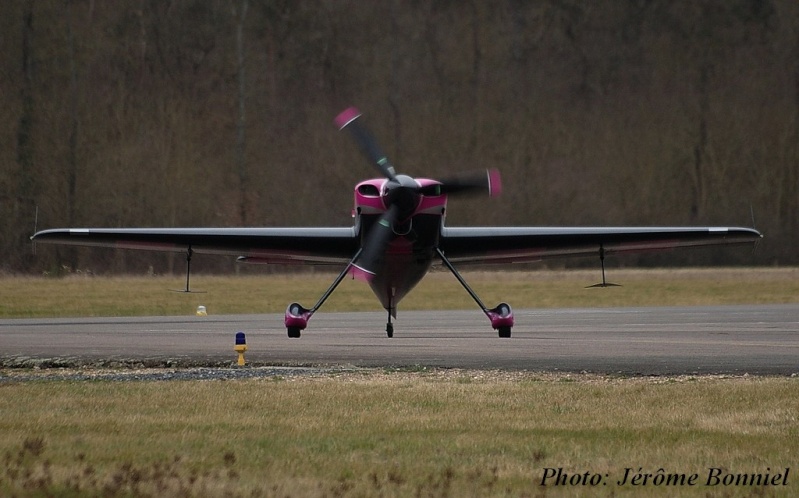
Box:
xmin=31 ymin=107 xmax=762 ymax=338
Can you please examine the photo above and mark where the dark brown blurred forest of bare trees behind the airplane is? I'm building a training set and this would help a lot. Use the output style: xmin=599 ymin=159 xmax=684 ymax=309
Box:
xmin=0 ymin=0 xmax=799 ymax=273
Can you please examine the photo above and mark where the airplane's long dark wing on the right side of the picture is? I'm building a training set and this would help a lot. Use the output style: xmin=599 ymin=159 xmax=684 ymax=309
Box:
xmin=439 ymin=227 xmax=762 ymax=263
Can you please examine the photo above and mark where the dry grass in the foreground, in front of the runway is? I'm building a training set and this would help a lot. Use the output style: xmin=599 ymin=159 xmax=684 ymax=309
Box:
xmin=0 ymin=370 xmax=799 ymax=496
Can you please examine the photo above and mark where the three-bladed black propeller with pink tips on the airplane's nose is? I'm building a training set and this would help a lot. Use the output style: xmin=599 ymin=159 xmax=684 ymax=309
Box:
xmin=334 ymin=107 xmax=502 ymax=280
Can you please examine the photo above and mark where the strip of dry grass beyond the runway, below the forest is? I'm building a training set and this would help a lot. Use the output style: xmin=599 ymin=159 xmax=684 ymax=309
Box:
xmin=0 ymin=268 xmax=799 ymax=318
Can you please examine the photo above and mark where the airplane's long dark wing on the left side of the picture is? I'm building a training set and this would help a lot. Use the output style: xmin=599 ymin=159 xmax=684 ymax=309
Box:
xmin=31 ymin=227 xmax=359 ymax=264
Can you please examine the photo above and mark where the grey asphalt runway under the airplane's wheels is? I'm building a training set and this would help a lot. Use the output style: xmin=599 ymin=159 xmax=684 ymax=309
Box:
xmin=0 ymin=304 xmax=799 ymax=375
